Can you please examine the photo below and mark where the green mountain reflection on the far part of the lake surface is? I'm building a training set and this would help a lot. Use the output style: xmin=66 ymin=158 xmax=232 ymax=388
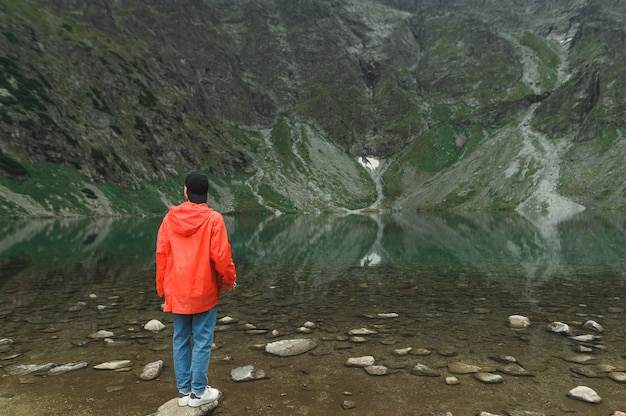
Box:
xmin=0 ymin=212 xmax=626 ymax=288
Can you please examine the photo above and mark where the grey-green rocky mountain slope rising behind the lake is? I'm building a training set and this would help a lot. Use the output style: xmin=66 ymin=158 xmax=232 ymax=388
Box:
xmin=0 ymin=0 xmax=626 ymax=219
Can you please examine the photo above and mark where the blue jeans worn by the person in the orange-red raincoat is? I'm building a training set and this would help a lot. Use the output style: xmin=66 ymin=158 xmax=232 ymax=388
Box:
xmin=172 ymin=306 xmax=217 ymax=395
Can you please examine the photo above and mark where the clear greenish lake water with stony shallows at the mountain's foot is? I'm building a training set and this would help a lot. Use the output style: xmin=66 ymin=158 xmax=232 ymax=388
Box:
xmin=0 ymin=212 xmax=626 ymax=416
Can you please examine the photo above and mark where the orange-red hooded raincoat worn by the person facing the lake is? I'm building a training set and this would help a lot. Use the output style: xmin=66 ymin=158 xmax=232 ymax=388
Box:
xmin=156 ymin=201 xmax=237 ymax=314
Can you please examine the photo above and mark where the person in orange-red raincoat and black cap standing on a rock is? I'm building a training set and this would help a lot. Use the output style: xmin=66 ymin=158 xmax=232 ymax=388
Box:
xmin=156 ymin=172 xmax=237 ymax=407
